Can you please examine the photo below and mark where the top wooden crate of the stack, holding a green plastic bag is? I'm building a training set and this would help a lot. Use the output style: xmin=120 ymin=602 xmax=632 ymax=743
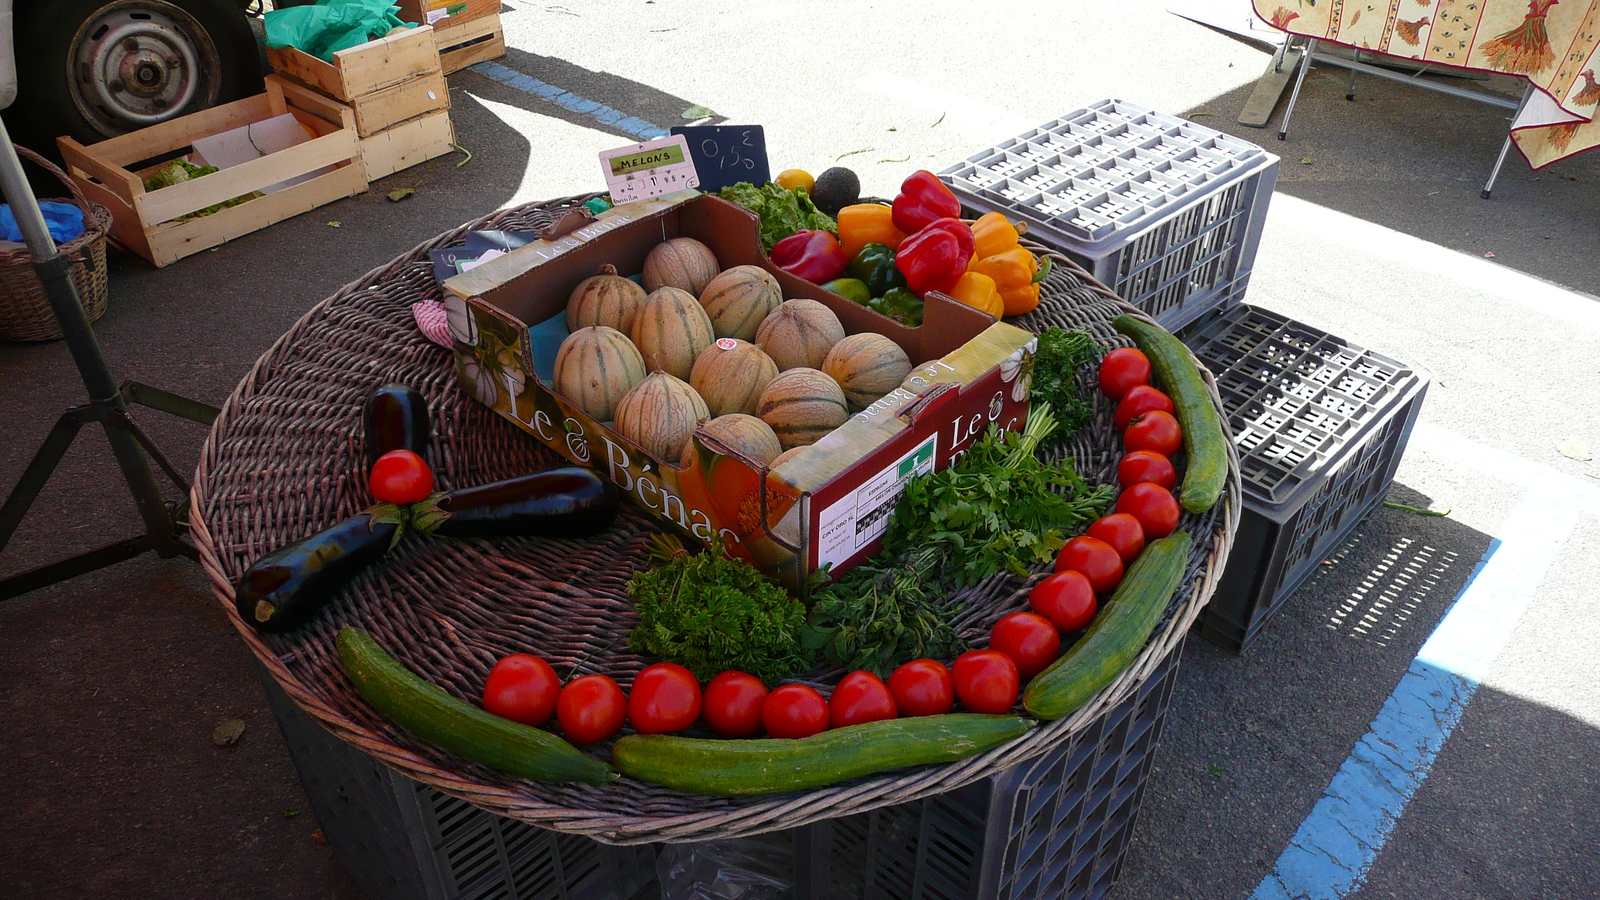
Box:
xmin=267 ymin=26 xmax=440 ymax=102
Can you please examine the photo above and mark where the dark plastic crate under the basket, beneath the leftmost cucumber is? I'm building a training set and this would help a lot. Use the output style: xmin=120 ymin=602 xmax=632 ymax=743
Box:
xmin=258 ymin=669 xmax=656 ymax=900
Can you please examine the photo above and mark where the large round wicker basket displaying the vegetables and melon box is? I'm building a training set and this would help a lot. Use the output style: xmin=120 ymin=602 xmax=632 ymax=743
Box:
xmin=192 ymin=197 xmax=1240 ymax=844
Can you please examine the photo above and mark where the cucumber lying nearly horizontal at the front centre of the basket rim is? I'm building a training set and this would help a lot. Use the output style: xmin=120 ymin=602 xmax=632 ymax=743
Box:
xmin=611 ymin=713 xmax=1034 ymax=798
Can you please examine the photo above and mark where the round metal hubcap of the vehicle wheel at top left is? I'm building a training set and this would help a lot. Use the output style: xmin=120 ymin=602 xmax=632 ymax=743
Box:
xmin=70 ymin=0 xmax=221 ymax=136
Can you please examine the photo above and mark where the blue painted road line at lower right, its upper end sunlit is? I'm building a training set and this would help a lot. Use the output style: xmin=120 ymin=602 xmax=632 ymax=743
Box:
xmin=1251 ymin=485 xmax=1578 ymax=900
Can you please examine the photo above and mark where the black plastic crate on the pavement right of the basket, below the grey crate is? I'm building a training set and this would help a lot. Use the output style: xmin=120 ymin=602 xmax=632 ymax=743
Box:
xmin=1184 ymin=304 xmax=1427 ymax=653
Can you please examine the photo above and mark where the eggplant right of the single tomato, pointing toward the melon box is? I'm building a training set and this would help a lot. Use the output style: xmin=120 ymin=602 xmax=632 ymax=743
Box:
xmin=419 ymin=466 xmax=622 ymax=538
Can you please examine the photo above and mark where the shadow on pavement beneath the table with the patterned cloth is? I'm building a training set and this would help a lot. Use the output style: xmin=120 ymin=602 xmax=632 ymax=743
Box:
xmin=1184 ymin=67 xmax=1600 ymax=293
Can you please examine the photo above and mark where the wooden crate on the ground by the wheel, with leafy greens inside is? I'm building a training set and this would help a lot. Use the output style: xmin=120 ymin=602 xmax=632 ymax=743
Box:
xmin=56 ymin=75 xmax=366 ymax=266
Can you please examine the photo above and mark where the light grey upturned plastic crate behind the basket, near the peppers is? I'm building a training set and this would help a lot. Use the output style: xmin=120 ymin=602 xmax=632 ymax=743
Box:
xmin=939 ymin=99 xmax=1278 ymax=331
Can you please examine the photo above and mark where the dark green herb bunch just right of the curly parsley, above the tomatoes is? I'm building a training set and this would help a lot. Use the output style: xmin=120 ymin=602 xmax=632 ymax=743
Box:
xmin=802 ymin=548 xmax=966 ymax=677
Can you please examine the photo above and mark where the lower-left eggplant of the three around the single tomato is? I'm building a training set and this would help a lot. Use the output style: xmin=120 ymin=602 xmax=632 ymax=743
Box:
xmin=234 ymin=512 xmax=398 ymax=634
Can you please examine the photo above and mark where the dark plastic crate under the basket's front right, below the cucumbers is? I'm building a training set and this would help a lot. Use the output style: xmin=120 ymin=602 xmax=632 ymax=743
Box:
xmin=794 ymin=645 xmax=1182 ymax=900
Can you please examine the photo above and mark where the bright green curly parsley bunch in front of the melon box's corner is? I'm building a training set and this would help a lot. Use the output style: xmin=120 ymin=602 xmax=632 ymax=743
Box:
xmin=627 ymin=538 xmax=813 ymax=682
